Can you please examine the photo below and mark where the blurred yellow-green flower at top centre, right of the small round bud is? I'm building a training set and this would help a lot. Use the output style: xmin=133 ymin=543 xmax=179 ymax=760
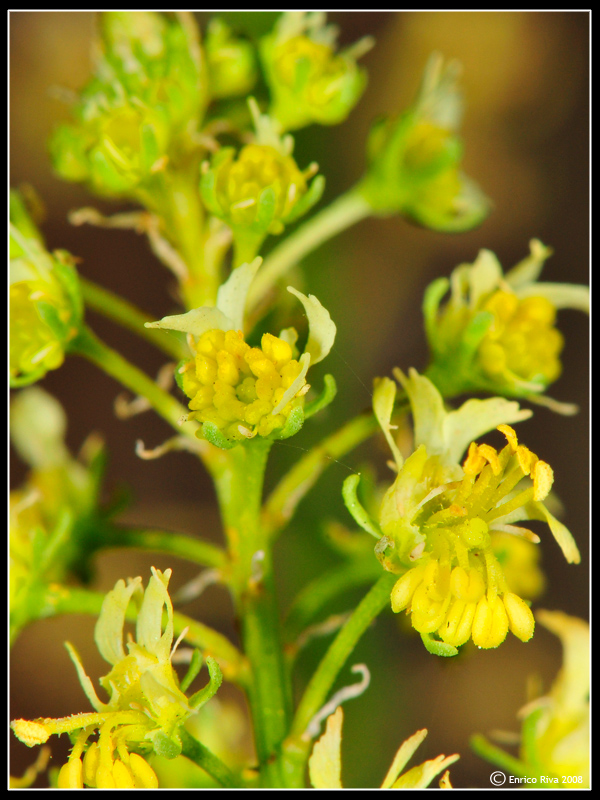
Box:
xmin=260 ymin=11 xmax=372 ymax=130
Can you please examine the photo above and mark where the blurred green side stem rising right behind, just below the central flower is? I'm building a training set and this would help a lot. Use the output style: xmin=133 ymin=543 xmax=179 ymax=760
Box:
xmin=263 ymin=411 xmax=379 ymax=535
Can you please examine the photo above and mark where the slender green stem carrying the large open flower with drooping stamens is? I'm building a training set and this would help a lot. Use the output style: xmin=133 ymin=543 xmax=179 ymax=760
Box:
xmin=284 ymin=572 xmax=398 ymax=787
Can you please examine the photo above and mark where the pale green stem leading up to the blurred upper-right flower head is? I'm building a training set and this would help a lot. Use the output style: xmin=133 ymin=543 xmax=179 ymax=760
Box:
xmin=247 ymin=187 xmax=372 ymax=312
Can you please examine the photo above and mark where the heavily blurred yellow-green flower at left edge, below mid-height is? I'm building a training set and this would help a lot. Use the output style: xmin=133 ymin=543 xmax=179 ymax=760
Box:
xmin=9 ymin=386 xmax=107 ymax=638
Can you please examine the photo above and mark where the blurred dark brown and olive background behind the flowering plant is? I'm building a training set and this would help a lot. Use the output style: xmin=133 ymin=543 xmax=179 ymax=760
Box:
xmin=10 ymin=12 xmax=589 ymax=788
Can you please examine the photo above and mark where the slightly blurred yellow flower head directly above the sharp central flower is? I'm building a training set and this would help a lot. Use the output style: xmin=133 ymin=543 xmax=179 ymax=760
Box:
xmin=200 ymin=101 xmax=325 ymax=263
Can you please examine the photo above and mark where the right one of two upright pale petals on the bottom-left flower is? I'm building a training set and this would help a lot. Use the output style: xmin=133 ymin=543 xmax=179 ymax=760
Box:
xmin=136 ymin=567 xmax=173 ymax=661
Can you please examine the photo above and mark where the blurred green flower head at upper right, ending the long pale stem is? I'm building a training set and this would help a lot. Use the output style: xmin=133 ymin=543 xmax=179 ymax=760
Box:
xmin=361 ymin=54 xmax=489 ymax=232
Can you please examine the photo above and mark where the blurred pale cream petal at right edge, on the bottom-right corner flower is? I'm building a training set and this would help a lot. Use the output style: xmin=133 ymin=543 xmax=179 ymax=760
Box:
xmin=535 ymin=609 xmax=590 ymax=714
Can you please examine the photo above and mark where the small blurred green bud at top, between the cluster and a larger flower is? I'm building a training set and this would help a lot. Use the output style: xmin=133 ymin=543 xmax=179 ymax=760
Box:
xmin=204 ymin=19 xmax=258 ymax=98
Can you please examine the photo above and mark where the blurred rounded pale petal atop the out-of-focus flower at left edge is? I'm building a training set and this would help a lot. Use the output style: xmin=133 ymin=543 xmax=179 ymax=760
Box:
xmin=10 ymin=386 xmax=69 ymax=469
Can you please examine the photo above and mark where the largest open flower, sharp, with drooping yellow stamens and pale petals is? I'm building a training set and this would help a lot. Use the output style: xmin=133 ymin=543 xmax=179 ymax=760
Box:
xmin=349 ymin=370 xmax=580 ymax=655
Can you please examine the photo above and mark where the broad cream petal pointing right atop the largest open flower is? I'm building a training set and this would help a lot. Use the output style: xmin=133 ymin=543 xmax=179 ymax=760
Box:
xmin=443 ymin=397 xmax=532 ymax=463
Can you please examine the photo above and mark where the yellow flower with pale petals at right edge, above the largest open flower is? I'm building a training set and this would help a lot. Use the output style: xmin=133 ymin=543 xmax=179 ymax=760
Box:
xmin=423 ymin=239 xmax=589 ymax=411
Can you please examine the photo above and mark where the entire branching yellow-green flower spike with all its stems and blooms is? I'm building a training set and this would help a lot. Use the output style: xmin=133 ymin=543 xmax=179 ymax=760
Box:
xmin=10 ymin=11 xmax=589 ymax=788
